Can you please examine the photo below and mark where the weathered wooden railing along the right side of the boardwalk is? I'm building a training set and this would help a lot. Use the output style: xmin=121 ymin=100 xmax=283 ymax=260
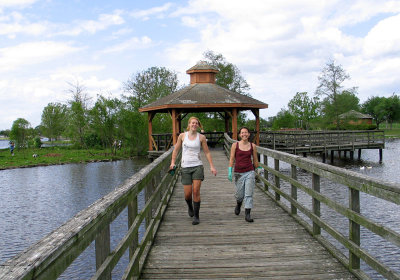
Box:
xmin=225 ymin=134 xmax=400 ymax=279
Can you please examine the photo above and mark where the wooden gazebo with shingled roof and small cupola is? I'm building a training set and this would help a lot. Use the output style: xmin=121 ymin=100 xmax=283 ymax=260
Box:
xmin=139 ymin=61 xmax=268 ymax=151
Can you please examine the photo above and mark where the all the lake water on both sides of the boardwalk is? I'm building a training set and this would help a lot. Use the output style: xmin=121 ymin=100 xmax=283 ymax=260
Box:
xmin=0 ymin=139 xmax=400 ymax=279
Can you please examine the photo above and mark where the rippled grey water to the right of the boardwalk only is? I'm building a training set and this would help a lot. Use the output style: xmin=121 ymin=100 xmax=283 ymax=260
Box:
xmin=268 ymin=139 xmax=400 ymax=279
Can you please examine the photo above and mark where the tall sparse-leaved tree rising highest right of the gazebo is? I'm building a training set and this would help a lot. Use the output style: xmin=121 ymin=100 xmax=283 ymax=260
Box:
xmin=316 ymin=61 xmax=356 ymax=128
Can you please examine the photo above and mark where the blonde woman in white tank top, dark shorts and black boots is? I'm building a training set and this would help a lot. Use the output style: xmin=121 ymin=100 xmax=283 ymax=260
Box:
xmin=170 ymin=117 xmax=217 ymax=225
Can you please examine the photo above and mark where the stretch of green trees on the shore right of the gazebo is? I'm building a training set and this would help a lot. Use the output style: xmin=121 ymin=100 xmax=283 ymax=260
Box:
xmin=267 ymin=61 xmax=400 ymax=129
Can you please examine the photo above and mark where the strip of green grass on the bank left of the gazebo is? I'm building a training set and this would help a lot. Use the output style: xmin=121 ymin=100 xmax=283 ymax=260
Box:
xmin=0 ymin=147 xmax=134 ymax=170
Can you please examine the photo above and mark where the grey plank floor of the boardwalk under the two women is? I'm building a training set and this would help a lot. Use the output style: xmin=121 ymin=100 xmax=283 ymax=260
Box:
xmin=141 ymin=150 xmax=356 ymax=279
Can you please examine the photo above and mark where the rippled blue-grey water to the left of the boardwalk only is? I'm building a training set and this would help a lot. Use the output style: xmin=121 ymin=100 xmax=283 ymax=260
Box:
xmin=0 ymin=158 xmax=149 ymax=279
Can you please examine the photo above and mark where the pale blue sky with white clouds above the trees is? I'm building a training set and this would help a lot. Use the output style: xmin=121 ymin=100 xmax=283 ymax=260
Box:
xmin=0 ymin=0 xmax=400 ymax=130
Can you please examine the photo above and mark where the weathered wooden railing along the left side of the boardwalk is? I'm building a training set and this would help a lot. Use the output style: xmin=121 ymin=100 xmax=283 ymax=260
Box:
xmin=0 ymin=149 xmax=180 ymax=280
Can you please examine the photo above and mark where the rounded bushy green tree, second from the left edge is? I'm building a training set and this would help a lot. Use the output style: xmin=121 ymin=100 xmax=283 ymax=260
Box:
xmin=41 ymin=103 xmax=67 ymax=141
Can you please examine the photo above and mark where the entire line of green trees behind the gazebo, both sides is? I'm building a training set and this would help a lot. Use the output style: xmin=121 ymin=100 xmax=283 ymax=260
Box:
xmin=0 ymin=54 xmax=400 ymax=155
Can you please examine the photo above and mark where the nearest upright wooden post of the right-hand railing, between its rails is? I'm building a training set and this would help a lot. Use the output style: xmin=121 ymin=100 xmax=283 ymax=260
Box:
xmin=349 ymin=188 xmax=361 ymax=269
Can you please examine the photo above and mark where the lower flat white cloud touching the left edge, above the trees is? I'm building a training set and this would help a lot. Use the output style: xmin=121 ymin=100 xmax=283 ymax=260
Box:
xmin=0 ymin=41 xmax=80 ymax=72
